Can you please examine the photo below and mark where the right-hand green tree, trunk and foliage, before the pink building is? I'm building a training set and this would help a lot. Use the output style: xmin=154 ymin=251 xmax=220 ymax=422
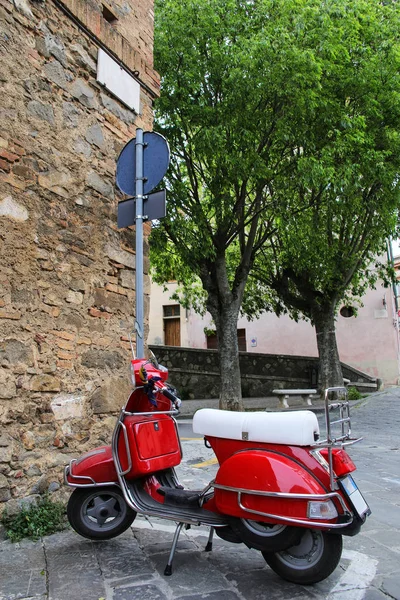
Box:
xmin=245 ymin=3 xmax=400 ymax=389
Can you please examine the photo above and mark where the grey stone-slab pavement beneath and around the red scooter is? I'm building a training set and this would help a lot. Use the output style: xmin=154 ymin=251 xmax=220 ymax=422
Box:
xmin=0 ymin=388 xmax=400 ymax=600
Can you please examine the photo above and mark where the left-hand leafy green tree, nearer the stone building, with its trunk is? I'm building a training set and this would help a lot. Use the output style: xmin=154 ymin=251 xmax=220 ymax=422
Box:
xmin=151 ymin=0 xmax=399 ymax=409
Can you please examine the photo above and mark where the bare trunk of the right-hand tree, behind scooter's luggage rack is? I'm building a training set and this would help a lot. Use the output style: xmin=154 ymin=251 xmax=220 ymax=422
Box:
xmin=312 ymin=306 xmax=343 ymax=392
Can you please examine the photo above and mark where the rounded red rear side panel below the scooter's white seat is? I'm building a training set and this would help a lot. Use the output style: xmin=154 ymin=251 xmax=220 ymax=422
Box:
xmin=215 ymin=449 xmax=337 ymax=526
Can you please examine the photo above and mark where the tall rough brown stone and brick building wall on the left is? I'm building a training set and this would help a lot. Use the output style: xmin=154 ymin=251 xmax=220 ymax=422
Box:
xmin=0 ymin=0 xmax=159 ymax=513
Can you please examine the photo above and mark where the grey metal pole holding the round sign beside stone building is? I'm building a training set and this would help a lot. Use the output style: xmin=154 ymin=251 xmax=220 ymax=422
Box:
xmin=135 ymin=129 xmax=144 ymax=358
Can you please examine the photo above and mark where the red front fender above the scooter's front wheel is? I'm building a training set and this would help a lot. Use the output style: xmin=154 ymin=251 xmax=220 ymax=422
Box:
xmin=64 ymin=446 xmax=118 ymax=487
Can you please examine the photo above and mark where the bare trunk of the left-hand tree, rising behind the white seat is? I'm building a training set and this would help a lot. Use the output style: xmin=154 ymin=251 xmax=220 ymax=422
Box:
xmin=214 ymin=303 xmax=244 ymax=411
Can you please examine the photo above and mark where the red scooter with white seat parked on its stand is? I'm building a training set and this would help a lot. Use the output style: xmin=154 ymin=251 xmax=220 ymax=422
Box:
xmin=65 ymin=357 xmax=370 ymax=584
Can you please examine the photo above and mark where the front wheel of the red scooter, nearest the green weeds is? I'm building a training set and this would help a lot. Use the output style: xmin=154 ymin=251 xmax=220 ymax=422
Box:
xmin=67 ymin=486 xmax=136 ymax=540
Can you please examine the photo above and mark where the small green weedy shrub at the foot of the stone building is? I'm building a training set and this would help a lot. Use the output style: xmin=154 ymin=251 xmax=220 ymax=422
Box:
xmin=1 ymin=496 xmax=67 ymax=542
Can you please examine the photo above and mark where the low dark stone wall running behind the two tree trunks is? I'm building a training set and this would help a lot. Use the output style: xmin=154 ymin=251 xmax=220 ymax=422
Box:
xmin=149 ymin=346 xmax=379 ymax=400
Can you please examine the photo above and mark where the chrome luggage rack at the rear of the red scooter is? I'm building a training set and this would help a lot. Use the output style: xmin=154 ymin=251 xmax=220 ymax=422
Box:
xmin=313 ymin=386 xmax=363 ymax=490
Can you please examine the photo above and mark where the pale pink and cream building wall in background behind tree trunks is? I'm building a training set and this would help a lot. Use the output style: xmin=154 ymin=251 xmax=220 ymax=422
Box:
xmin=149 ymin=283 xmax=399 ymax=385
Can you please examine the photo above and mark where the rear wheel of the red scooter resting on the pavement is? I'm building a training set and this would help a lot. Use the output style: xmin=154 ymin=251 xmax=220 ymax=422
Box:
xmin=262 ymin=529 xmax=343 ymax=585
